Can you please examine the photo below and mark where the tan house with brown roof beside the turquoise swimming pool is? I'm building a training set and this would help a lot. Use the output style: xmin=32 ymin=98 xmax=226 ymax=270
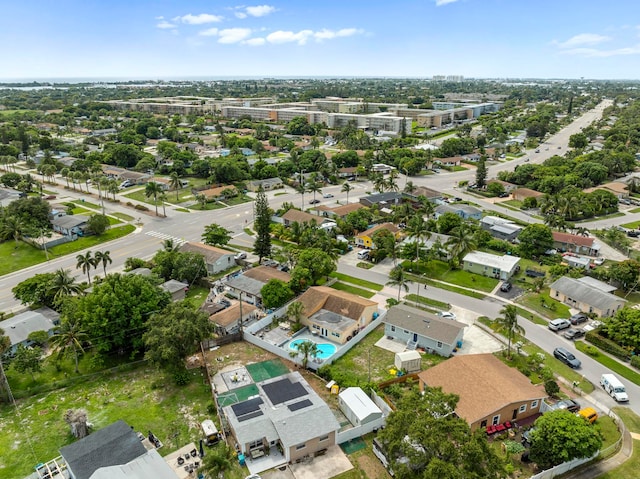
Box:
xmin=297 ymin=286 xmax=378 ymax=344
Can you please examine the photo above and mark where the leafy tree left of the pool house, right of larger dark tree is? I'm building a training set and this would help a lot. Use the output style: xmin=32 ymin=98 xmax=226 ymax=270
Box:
xmin=143 ymin=302 xmax=213 ymax=370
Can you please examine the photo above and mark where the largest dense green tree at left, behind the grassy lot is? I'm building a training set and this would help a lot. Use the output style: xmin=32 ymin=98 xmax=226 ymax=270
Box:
xmin=71 ymin=273 xmax=170 ymax=354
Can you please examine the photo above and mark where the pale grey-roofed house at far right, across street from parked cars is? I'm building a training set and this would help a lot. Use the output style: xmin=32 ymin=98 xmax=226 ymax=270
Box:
xmin=549 ymin=276 xmax=626 ymax=317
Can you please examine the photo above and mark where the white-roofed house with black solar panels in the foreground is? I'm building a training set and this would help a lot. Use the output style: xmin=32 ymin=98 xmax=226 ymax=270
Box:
xmin=222 ymin=371 xmax=340 ymax=468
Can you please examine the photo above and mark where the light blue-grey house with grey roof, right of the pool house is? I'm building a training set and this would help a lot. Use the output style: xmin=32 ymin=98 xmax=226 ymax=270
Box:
xmin=384 ymin=304 xmax=466 ymax=357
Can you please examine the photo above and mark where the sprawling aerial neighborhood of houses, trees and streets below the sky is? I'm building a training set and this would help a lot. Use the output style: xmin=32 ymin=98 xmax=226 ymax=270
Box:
xmin=0 ymin=75 xmax=640 ymax=479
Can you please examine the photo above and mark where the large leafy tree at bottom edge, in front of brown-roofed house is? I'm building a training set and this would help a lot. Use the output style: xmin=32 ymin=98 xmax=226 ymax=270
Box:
xmin=378 ymin=387 xmax=507 ymax=479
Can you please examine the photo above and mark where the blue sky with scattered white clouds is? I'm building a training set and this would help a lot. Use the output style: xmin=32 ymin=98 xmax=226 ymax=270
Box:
xmin=0 ymin=0 xmax=640 ymax=79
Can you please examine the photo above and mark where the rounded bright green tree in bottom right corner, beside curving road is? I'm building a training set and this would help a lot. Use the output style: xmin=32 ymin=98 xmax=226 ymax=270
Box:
xmin=530 ymin=409 xmax=602 ymax=469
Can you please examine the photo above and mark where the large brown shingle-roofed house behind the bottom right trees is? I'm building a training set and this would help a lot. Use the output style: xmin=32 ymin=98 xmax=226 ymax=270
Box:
xmin=418 ymin=354 xmax=547 ymax=430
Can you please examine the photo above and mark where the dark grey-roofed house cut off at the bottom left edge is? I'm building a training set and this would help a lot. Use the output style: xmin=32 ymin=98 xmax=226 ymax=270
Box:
xmin=60 ymin=420 xmax=147 ymax=479
